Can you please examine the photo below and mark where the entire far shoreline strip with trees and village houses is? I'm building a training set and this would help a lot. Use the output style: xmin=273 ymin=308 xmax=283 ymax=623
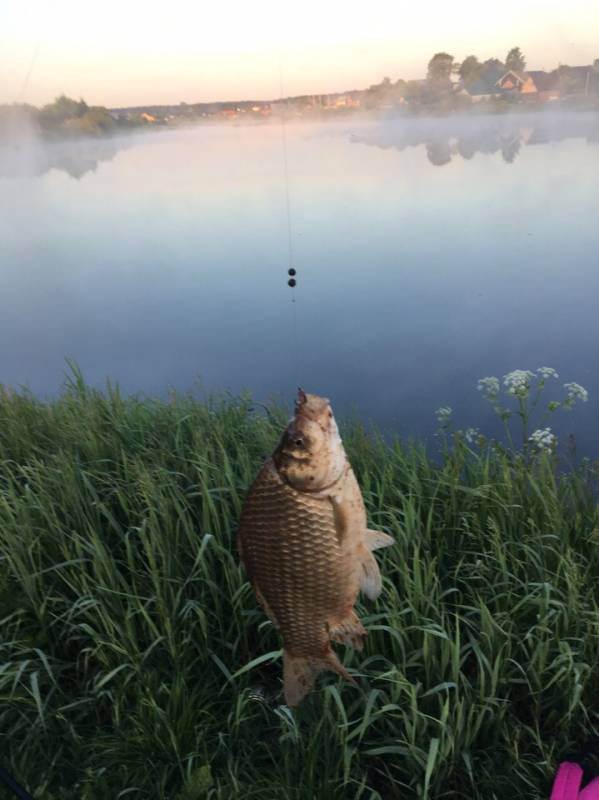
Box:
xmin=0 ymin=47 xmax=599 ymax=142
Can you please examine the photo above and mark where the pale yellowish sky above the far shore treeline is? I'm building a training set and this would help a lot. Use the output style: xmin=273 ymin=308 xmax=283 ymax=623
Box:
xmin=0 ymin=0 xmax=599 ymax=107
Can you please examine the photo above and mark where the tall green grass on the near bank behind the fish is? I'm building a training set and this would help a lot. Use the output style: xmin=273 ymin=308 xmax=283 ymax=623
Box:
xmin=0 ymin=372 xmax=599 ymax=800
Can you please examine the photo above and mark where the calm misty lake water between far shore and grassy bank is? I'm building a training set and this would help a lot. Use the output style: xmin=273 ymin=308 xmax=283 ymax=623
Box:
xmin=0 ymin=114 xmax=599 ymax=450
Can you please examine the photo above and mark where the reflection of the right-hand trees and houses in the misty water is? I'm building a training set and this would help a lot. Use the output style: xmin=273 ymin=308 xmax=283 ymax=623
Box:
xmin=350 ymin=113 xmax=599 ymax=167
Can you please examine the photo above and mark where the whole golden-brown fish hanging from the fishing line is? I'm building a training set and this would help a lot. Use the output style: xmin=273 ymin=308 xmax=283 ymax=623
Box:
xmin=237 ymin=389 xmax=394 ymax=708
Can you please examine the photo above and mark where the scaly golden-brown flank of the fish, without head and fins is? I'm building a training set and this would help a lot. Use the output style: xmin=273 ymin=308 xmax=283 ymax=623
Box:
xmin=240 ymin=462 xmax=350 ymax=655
